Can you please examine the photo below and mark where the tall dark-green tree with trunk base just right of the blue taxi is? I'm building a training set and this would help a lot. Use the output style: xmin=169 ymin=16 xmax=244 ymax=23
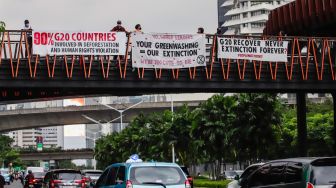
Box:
xmin=192 ymin=95 xmax=237 ymax=177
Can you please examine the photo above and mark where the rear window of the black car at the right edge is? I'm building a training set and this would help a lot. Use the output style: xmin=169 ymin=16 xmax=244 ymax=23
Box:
xmin=311 ymin=166 xmax=336 ymax=185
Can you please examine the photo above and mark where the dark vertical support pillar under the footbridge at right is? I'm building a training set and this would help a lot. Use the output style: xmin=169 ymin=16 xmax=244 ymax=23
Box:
xmin=296 ymin=92 xmax=308 ymax=157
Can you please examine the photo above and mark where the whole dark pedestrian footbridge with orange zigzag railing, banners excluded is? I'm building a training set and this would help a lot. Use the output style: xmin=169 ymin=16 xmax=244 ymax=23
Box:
xmin=0 ymin=30 xmax=336 ymax=102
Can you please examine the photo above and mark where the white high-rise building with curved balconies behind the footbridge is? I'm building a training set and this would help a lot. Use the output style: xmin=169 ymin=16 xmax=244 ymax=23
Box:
xmin=218 ymin=0 xmax=293 ymax=35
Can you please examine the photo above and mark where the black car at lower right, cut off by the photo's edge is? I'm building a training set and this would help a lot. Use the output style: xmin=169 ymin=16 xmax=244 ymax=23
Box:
xmin=240 ymin=157 xmax=336 ymax=188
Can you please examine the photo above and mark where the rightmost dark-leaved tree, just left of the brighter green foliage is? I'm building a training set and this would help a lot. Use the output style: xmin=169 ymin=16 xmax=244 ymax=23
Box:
xmin=233 ymin=93 xmax=281 ymax=161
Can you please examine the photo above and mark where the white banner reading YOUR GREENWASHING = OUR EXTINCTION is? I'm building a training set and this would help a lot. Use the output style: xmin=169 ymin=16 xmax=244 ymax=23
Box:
xmin=131 ymin=33 xmax=206 ymax=69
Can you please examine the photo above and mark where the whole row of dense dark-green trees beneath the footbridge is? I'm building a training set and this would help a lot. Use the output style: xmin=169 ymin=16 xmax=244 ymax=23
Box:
xmin=95 ymin=94 xmax=288 ymax=173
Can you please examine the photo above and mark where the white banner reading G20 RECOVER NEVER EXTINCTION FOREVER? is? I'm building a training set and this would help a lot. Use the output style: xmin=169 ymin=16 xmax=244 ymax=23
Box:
xmin=218 ymin=38 xmax=288 ymax=62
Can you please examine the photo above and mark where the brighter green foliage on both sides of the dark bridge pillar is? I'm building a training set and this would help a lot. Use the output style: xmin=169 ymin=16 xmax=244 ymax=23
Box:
xmin=278 ymin=100 xmax=334 ymax=158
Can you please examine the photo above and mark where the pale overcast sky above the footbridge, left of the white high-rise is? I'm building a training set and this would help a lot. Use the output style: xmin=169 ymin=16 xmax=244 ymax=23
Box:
xmin=0 ymin=0 xmax=218 ymax=33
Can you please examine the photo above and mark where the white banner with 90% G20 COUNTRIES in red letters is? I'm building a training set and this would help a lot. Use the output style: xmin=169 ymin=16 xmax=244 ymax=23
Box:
xmin=33 ymin=31 xmax=127 ymax=55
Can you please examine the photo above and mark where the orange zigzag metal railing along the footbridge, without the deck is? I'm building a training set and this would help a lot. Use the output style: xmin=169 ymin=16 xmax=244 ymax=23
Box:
xmin=0 ymin=30 xmax=336 ymax=81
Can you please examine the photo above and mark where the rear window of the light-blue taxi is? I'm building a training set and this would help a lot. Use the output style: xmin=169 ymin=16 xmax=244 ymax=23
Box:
xmin=130 ymin=166 xmax=186 ymax=185
